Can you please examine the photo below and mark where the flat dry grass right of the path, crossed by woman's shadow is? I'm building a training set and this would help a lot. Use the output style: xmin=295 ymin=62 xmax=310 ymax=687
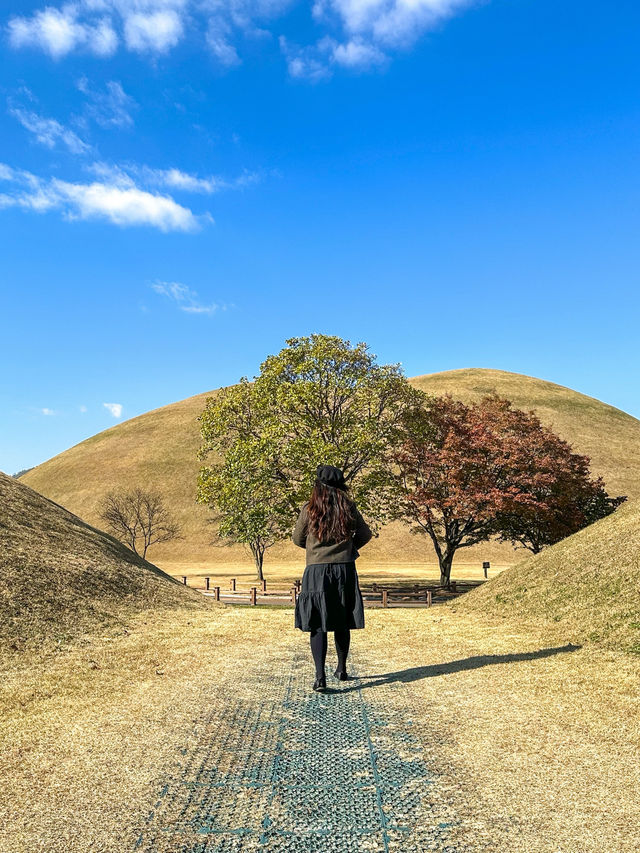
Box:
xmin=363 ymin=606 xmax=640 ymax=853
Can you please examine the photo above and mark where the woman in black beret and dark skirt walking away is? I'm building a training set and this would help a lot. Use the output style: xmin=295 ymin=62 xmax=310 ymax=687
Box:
xmin=293 ymin=465 xmax=373 ymax=691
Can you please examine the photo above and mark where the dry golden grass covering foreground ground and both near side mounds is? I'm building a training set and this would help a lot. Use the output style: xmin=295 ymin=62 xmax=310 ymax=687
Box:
xmin=7 ymin=412 xmax=640 ymax=853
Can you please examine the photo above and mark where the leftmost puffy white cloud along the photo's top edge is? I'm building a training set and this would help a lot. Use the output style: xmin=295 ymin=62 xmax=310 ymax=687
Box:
xmin=8 ymin=3 xmax=118 ymax=59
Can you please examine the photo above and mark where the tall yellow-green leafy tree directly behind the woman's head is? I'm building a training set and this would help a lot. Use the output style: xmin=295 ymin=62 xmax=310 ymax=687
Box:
xmin=198 ymin=335 xmax=422 ymax=572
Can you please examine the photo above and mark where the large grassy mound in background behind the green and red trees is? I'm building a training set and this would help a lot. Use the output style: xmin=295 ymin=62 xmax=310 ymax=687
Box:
xmin=20 ymin=368 xmax=640 ymax=571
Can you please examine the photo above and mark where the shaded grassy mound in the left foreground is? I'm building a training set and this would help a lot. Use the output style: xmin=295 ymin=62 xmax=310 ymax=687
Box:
xmin=0 ymin=473 xmax=206 ymax=648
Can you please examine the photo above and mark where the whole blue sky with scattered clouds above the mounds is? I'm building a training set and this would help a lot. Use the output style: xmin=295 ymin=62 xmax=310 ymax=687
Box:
xmin=0 ymin=0 xmax=640 ymax=473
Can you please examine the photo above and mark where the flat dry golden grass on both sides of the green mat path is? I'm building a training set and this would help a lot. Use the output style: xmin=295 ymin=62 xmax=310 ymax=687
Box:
xmin=0 ymin=606 xmax=640 ymax=853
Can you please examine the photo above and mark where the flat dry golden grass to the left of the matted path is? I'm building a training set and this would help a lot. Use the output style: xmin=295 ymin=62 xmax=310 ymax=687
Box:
xmin=0 ymin=607 xmax=278 ymax=853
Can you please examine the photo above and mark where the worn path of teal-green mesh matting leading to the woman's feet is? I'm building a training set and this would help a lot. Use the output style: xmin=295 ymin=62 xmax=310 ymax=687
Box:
xmin=136 ymin=635 xmax=470 ymax=853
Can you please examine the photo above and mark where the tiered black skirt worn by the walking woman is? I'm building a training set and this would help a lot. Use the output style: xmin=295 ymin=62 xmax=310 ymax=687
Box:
xmin=295 ymin=561 xmax=364 ymax=631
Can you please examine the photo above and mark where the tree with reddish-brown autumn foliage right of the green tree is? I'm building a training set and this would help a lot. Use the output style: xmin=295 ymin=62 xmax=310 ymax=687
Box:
xmin=393 ymin=395 xmax=624 ymax=585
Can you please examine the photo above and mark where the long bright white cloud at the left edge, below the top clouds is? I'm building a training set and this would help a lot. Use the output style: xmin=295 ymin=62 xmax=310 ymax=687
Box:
xmin=0 ymin=164 xmax=205 ymax=232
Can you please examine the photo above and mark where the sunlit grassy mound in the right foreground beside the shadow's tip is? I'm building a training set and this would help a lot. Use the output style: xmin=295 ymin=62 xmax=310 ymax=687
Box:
xmin=455 ymin=500 xmax=640 ymax=653
